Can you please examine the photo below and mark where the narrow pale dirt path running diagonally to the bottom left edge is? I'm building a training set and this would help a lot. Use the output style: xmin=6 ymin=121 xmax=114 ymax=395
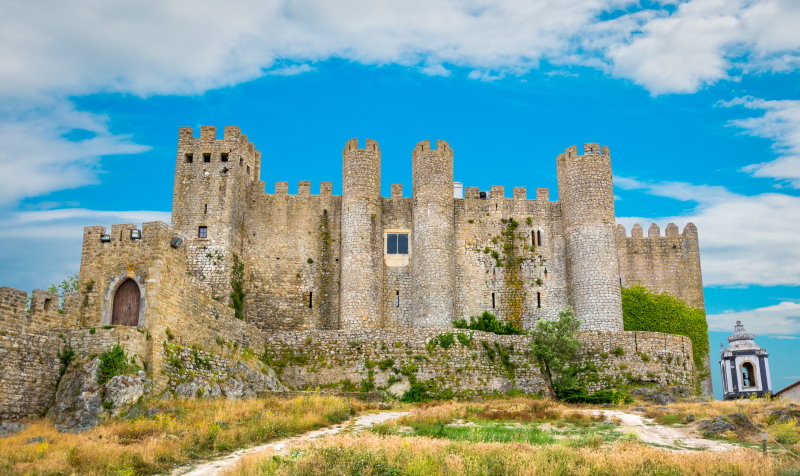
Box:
xmin=170 ymin=412 xmax=408 ymax=476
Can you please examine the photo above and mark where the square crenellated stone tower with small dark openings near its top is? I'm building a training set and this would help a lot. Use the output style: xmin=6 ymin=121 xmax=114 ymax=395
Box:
xmin=172 ymin=126 xmax=261 ymax=302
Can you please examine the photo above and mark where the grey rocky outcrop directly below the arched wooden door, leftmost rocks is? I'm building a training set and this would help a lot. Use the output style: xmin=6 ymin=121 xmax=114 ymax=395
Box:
xmin=48 ymin=359 xmax=150 ymax=433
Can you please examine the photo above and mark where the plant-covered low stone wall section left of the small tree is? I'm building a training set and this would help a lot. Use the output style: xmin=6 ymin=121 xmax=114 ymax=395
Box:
xmin=265 ymin=329 xmax=546 ymax=395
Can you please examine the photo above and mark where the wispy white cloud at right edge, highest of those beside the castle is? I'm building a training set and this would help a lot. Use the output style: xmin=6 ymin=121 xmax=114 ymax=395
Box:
xmin=719 ymin=97 xmax=800 ymax=188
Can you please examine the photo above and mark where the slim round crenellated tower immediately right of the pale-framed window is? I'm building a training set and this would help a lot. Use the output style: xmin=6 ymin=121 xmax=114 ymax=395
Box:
xmin=411 ymin=140 xmax=456 ymax=327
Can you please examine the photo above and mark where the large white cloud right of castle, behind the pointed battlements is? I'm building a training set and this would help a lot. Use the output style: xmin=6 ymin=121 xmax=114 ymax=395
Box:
xmin=615 ymin=177 xmax=800 ymax=286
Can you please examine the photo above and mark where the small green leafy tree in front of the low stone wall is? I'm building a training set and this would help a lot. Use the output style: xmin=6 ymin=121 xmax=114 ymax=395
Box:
xmin=531 ymin=307 xmax=581 ymax=398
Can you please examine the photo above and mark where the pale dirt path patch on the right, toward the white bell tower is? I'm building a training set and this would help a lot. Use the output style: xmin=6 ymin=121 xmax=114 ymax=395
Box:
xmin=592 ymin=410 xmax=738 ymax=451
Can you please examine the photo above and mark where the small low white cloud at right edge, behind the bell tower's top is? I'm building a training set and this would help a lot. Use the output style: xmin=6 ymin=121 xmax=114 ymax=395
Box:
xmin=708 ymin=302 xmax=800 ymax=339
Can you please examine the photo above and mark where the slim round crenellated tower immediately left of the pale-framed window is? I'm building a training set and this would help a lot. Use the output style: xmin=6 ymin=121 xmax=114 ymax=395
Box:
xmin=339 ymin=139 xmax=383 ymax=329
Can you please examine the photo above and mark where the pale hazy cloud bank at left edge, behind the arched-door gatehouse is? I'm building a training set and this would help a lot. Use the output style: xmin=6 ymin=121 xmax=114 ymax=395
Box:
xmin=0 ymin=209 xmax=170 ymax=290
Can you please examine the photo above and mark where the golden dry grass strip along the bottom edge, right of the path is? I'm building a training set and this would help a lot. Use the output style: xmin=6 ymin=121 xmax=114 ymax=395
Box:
xmin=225 ymin=434 xmax=800 ymax=476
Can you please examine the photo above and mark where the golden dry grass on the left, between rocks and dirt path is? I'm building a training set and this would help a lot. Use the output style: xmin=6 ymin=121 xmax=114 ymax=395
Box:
xmin=0 ymin=396 xmax=368 ymax=475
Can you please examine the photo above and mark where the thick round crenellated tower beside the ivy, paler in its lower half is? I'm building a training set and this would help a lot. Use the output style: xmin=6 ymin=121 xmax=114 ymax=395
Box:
xmin=556 ymin=143 xmax=623 ymax=331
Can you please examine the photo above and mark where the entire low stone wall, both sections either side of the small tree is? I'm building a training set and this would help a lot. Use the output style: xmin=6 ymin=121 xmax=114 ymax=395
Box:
xmin=265 ymin=329 xmax=694 ymax=395
